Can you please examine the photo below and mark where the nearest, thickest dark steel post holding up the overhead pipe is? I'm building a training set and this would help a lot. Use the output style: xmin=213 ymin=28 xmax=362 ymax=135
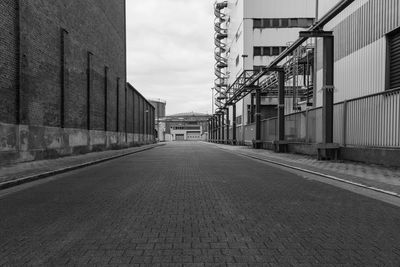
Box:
xmin=322 ymin=36 xmax=334 ymax=143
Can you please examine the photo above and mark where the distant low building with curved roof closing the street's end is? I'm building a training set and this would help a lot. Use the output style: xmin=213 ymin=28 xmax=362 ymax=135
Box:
xmin=159 ymin=112 xmax=211 ymax=141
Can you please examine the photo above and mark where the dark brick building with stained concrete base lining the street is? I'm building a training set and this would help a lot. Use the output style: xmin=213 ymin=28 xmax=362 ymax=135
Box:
xmin=0 ymin=0 xmax=154 ymax=164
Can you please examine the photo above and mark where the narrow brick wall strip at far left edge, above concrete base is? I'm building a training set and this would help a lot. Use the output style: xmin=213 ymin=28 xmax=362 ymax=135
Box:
xmin=0 ymin=0 xmax=18 ymax=123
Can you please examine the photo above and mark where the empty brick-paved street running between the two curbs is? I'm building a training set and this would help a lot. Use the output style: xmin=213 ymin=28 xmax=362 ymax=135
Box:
xmin=0 ymin=143 xmax=400 ymax=266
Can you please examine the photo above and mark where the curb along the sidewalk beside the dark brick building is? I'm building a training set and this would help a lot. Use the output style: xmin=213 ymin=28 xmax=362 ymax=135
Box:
xmin=0 ymin=144 xmax=165 ymax=190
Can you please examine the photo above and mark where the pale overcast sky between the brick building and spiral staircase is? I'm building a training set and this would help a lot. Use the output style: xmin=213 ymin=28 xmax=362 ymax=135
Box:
xmin=126 ymin=0 xmax=214 ymax=114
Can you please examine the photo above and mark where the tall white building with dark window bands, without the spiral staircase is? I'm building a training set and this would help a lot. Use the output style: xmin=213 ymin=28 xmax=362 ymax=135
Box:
xmin=219 ymin=0 xmax=315 ymax=129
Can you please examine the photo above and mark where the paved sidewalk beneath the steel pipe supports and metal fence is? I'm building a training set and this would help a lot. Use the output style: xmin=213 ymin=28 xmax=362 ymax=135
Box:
xmin=215 ymin=144 xmax=400 ymax=196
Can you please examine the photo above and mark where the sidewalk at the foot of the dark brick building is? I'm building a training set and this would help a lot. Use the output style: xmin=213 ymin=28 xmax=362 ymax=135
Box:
xmin=0 ymin=144 xmax=163 ymax=189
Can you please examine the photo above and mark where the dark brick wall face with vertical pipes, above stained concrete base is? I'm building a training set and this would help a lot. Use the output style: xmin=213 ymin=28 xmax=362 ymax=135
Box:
xmin=17 ymin=0 xmax=126 ymax=131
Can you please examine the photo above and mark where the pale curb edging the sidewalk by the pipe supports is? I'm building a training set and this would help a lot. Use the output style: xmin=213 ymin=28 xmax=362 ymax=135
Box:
xmin=219 ymin=147 xmax=400 ymax=198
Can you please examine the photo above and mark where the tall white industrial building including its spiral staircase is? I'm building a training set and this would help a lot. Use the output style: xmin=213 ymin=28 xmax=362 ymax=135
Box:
xmin=215 ymin=0 xmax=315 ymax=144
